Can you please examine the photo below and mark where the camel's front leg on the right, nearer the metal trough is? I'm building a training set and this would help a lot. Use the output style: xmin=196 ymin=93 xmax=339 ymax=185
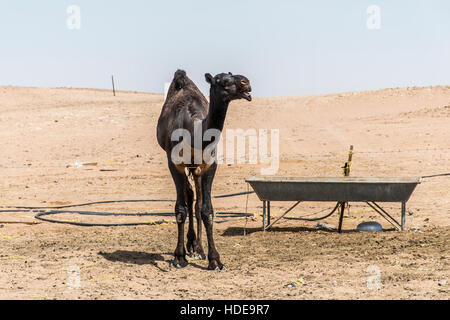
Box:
xmin=201 ymin=163 xmax=225 ymax=270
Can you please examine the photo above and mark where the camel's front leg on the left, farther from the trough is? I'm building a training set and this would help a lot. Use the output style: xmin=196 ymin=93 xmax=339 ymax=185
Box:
xmin=169 ymin=159 xmax=189 ymax=268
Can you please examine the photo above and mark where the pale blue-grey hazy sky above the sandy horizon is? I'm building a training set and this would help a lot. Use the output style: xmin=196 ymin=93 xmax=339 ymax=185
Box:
xmin=0 ymin=0 xmax=450 ymax=96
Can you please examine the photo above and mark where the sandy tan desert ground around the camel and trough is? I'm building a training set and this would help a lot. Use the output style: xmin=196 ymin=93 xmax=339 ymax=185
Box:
xmin=0 ymin=86 xmax=450 ymax=299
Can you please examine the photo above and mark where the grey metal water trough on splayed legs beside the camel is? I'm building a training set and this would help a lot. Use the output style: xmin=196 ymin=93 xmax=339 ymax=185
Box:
xmin=246 ymin=176 xmax=422 ymax=231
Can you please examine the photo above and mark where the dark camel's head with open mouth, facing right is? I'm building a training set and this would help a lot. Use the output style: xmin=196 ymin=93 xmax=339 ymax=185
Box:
xmin=205 ymin=72 xmax=252 ymax=101
